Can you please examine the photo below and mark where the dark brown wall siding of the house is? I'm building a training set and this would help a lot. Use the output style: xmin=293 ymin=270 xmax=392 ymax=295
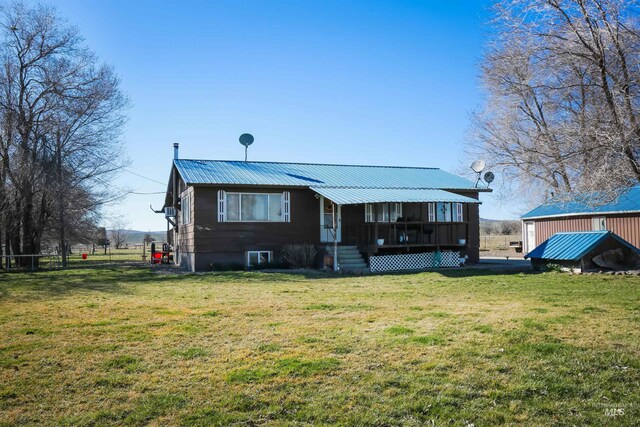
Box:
xmin=173 ymin=180 xmax=480 ymax=271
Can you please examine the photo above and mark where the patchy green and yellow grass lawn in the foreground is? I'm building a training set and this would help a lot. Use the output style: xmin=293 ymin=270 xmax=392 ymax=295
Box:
xmin=0 ymin=267 xmax=640 ymax=426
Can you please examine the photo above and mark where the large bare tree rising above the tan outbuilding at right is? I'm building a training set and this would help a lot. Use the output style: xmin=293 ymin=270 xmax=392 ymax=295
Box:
xmin=471 ymin=0 xmax=640 ymax=203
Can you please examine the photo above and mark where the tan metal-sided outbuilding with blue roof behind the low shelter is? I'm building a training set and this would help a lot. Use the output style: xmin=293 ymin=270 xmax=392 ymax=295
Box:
xmin=520 ymin=186 xmax=640 ymax=253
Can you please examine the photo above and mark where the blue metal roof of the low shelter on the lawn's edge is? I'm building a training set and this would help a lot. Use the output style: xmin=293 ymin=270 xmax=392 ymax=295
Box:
xmin=524 ymin=230 xmax=640 ymax=261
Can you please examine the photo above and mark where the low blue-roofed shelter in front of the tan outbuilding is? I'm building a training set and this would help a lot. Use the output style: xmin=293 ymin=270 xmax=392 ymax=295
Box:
xmin=524 ymin=231 xmax=640 ymax=271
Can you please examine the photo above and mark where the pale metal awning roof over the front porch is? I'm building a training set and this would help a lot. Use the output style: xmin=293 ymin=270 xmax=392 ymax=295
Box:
xmin=310 ymin=187 xmax=480 ymax=205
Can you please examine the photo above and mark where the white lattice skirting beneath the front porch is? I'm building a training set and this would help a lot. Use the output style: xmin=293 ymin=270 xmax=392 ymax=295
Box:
xmin=369 ymin=251 xmax=460 ymax=271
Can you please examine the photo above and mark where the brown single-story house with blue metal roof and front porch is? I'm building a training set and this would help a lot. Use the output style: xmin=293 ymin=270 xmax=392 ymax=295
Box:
xmin=163 ymin=149 xmax=488 ymax=271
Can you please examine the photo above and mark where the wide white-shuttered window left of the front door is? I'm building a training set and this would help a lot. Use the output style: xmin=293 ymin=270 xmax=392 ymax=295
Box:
xmin=218 ymin=190 xmax=291 ymax=222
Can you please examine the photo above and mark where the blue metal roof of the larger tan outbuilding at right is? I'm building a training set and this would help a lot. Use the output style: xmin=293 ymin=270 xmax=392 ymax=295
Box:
xmin=520 ymin=186 xmax=640 ymax=219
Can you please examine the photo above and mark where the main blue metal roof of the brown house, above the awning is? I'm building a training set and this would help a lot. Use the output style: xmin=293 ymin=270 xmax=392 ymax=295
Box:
xmin=174 ymin=159 xmax=486 ymax=191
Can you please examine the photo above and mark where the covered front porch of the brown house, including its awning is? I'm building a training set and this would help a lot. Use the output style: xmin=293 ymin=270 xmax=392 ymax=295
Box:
xmin=312 ymin=187 xmax=480 ymax=257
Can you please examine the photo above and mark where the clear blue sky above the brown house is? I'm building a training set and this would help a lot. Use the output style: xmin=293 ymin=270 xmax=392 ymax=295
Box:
xmin=38 ymin=0 xmax=517 ymax=230
